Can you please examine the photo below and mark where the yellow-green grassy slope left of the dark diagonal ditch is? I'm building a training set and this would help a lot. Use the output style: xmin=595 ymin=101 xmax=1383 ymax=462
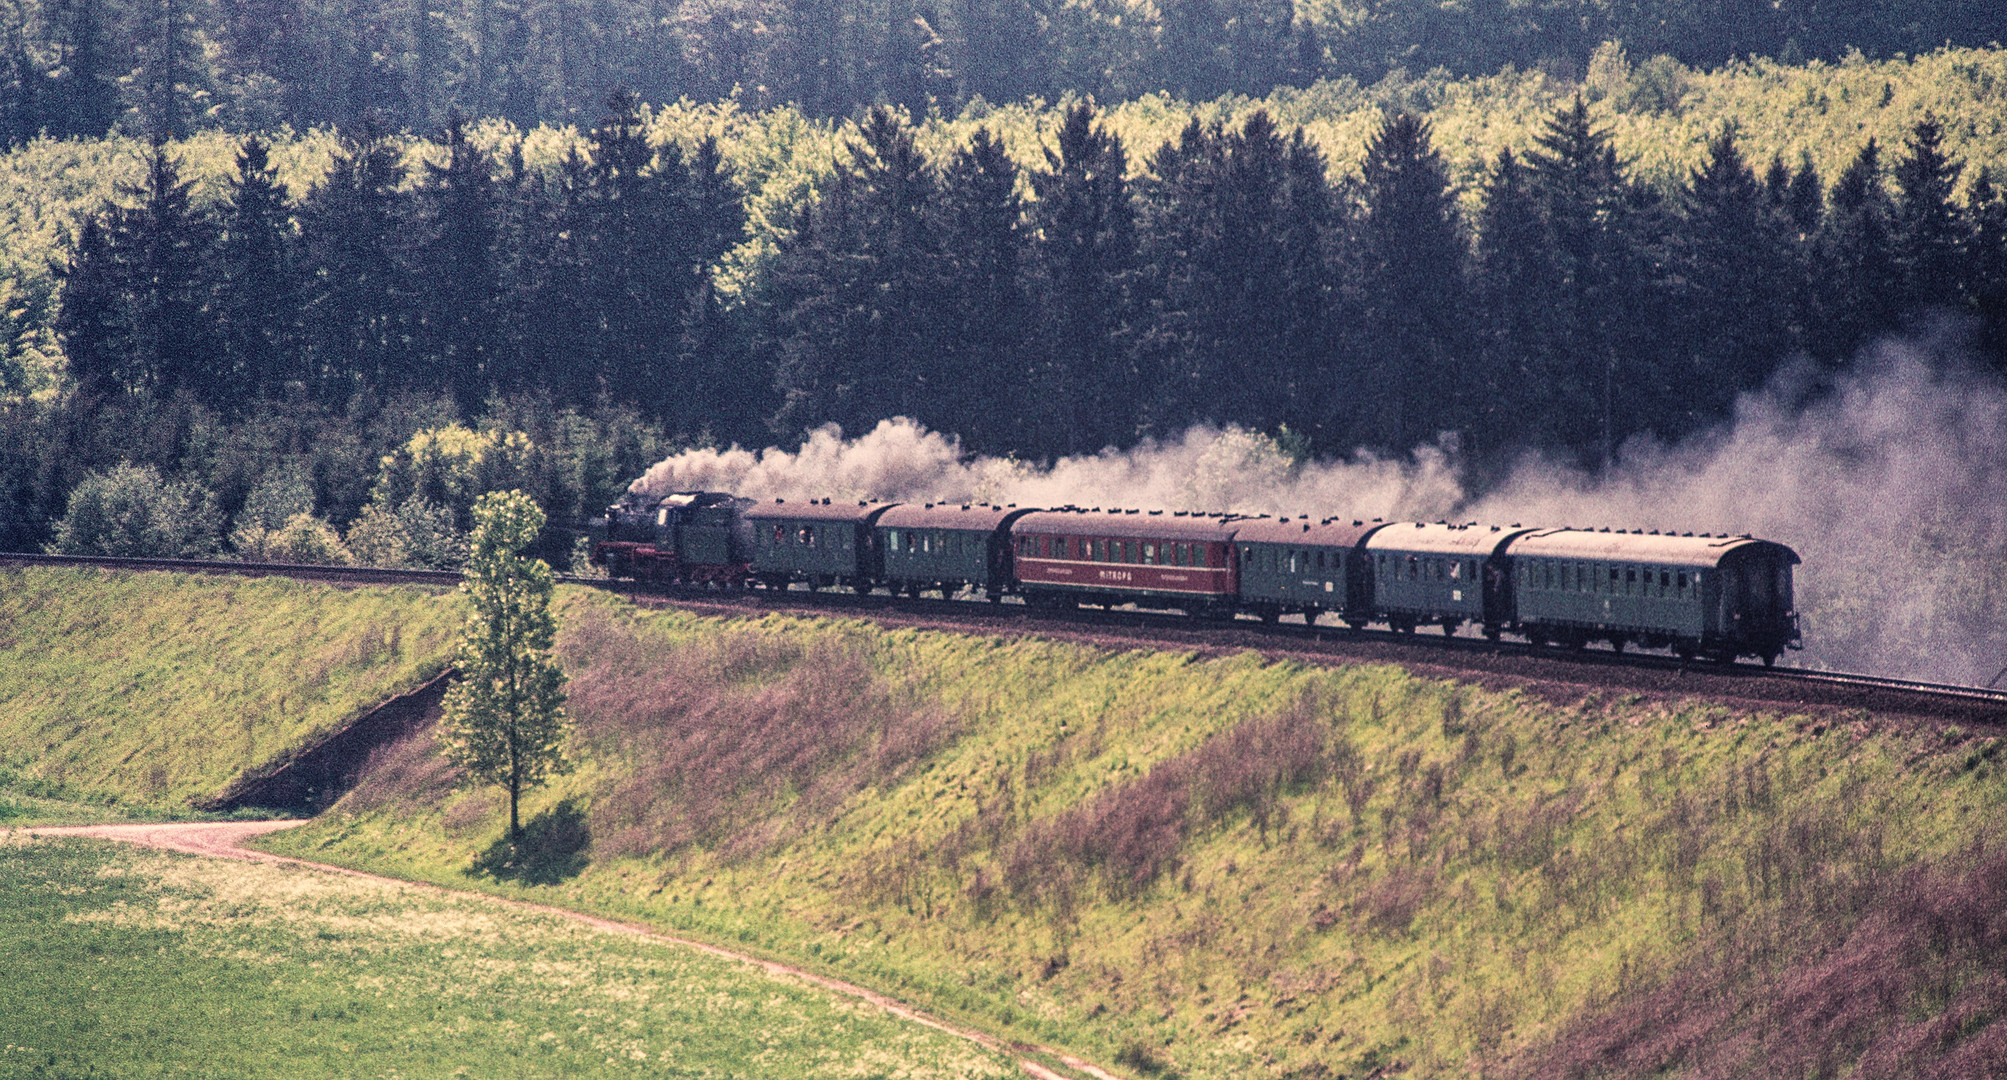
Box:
xmin=0 ymin=566 xmax=460 ymax=813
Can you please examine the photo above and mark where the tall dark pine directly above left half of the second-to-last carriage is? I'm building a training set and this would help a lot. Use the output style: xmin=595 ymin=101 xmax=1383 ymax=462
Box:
xmin=1359 ymin=112 xmax=1481 ymax=454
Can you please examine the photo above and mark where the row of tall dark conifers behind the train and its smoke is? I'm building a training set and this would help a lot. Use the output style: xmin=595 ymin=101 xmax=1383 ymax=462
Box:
xmin=15 ymin=94 xmax=2007 ymax=556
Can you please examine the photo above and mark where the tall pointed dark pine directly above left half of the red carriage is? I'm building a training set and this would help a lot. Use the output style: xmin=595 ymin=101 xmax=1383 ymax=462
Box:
xmin=1032 ymin=104 xmax=1140 ymax=454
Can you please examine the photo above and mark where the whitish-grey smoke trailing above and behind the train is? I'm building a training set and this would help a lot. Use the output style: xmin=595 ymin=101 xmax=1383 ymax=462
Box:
xmin=634 ymin=331 xmax=2007 ymax=685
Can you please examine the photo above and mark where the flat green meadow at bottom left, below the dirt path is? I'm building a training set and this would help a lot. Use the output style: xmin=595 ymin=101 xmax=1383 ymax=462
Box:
xmin=0 ymin=839 xmax=1018 ymax=1080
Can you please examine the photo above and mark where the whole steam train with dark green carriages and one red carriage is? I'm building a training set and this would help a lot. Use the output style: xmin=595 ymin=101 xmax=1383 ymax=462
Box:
xmin=592 ymin=492 xmax=1800 ymax=664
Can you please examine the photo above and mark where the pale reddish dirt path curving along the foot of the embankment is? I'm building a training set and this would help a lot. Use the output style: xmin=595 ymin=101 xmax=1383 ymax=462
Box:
xmin=8 ymin=821 xmax=1120 ymax=1080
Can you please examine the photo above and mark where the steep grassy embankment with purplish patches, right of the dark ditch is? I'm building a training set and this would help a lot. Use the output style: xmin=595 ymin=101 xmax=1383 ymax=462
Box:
xmin=271 ymin=594 xmax=2007 ymax=1078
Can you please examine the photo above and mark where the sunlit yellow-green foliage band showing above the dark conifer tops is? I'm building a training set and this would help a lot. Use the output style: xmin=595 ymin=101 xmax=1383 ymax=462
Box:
xmin=0 ymin=46 xmax=2007 ymax=389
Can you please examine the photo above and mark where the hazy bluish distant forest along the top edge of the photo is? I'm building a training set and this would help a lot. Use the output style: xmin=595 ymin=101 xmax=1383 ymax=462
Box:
xmin=0 ymin=0 xmax=2007 ymax=143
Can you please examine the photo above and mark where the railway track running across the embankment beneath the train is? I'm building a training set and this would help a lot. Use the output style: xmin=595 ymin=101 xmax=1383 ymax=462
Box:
xmin=15 ymin=552 xmax=2007 ymax=727
